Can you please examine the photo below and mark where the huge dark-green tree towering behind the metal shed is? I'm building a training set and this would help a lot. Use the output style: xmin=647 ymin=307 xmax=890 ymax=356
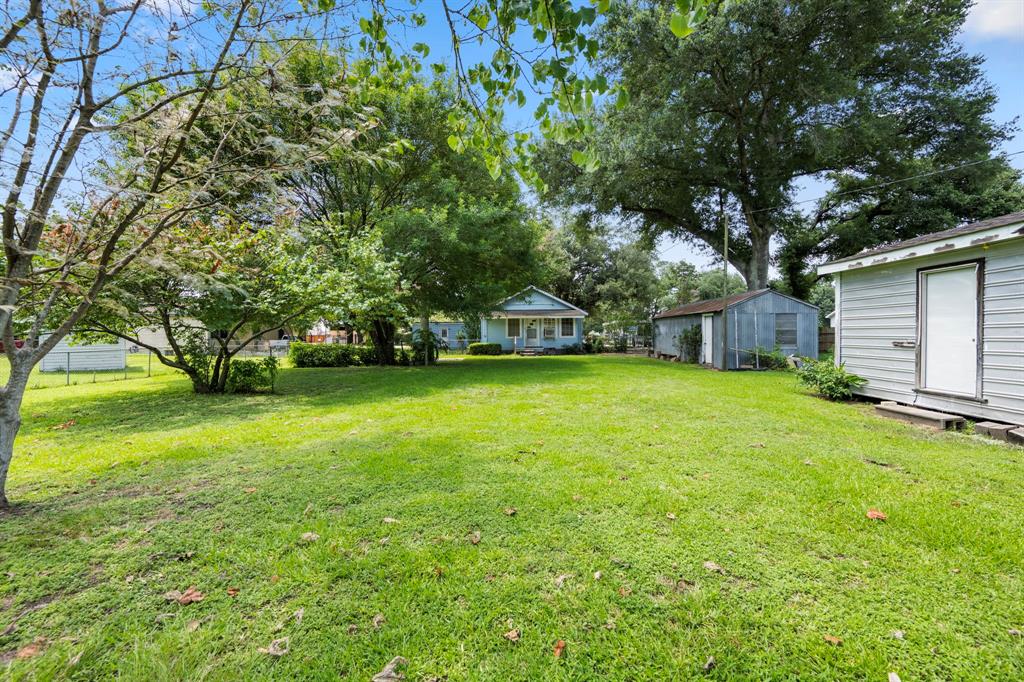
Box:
xmin=540 ymin=0 xmax=1015 ymax=289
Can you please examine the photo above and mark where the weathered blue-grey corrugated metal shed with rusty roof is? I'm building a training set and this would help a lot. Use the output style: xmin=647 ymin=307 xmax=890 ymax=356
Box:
xmin=654 ymin=289 xmax=818 ymax=370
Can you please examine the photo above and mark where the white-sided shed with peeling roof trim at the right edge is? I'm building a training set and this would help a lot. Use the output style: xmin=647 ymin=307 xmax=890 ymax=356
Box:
xmin=818 ymin=211 xmax=1024 ymax=424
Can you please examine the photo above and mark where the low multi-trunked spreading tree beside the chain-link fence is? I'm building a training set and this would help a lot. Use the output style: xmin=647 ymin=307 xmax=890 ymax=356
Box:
xmin=79 ymin=217 xmax=327 ymax=393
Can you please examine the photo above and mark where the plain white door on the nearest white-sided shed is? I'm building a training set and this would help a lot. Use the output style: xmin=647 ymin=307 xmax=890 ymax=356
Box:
xmin=920 ymin=263 xmax=978 ymax=396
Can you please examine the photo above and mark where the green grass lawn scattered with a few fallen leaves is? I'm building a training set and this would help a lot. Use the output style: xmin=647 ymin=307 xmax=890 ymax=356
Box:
xmin=0 ymin=356 xmax=1024 ymax=681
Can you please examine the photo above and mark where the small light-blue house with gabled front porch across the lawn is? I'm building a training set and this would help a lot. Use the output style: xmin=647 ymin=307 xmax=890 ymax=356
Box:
xmin=480 ymin=286 xmax=587 ymax=352
